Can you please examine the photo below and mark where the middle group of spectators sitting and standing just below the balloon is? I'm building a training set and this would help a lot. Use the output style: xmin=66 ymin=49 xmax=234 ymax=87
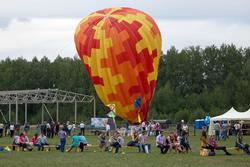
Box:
xmin=98 ymin=121 xmax=191 ymax=154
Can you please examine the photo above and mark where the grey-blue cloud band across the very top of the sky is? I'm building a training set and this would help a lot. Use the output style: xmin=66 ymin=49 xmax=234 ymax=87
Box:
xmin=0 ymin=0 xmax=250 ymax=21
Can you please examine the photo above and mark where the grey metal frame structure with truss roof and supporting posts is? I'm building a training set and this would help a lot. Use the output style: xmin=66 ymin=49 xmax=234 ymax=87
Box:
xmin=0 ymin=89 xmax=96 ymax=123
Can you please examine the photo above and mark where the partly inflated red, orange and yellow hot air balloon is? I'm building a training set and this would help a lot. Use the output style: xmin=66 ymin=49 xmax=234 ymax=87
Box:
xmin=75 ymin=7 xmax=162 ymax=124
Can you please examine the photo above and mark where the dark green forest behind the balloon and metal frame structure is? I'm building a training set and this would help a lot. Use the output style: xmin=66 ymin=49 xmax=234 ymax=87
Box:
xmin=0 ymin=44 xmax=250 ymax=123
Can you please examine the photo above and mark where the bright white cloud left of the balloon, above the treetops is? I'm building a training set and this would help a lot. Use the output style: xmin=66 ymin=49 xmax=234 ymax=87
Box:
xmin=0 ymin=18 xmax=79 ymax=59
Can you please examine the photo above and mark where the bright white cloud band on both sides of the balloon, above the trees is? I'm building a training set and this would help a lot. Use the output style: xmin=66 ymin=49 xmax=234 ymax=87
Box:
xmin=0 ymin=18 xmax=250 ymax=60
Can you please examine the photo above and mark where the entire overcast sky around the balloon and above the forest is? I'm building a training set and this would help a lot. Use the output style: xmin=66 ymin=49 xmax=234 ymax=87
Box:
xmin=0 ymin=0 xmax=250 ymax=60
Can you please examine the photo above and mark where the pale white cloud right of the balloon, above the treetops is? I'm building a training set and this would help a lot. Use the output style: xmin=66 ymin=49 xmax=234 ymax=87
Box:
xmin=158 ymin=20 xmax=250 ymax=51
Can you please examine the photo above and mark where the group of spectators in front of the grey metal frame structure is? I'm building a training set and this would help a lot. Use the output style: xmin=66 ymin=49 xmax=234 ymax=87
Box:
xmin=0 ymin=121 xmax=87 ymax=152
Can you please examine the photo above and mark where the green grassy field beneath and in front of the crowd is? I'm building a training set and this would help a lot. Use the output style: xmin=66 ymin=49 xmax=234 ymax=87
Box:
xmin=0 ymin=132 xmax=250 ymax=167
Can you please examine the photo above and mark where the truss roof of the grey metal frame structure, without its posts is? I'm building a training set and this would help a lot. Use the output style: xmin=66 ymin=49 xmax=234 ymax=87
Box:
xmin=0 ymin=89 xmax=95 ymax=104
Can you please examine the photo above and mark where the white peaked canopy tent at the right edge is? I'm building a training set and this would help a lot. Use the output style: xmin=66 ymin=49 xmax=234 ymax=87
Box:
xmin=209 ymin=107 xmax=250 ymax=135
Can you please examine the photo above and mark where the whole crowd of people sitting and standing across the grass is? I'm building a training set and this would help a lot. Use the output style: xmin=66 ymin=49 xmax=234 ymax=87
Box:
xmin=0 ymin=120 xmax=250 ymax=156
